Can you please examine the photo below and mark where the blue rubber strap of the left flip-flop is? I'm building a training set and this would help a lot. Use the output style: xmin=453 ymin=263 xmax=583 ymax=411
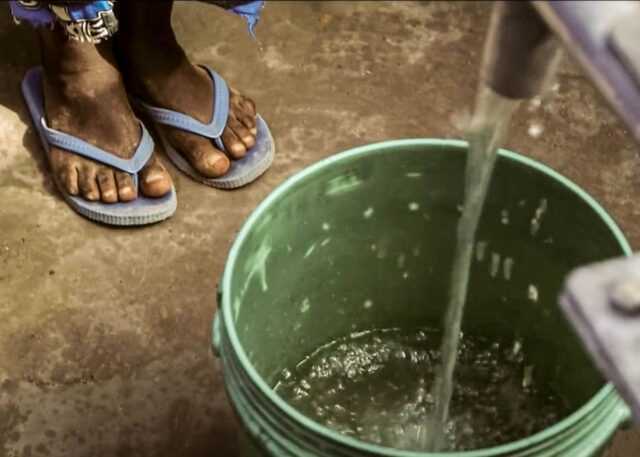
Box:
xmin=42 ymin=117 xmax=154 ymax=174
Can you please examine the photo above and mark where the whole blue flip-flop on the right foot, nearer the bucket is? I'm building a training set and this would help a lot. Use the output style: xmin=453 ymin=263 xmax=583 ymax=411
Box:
xmin=134 ymin=65 xmax=275 ymax=189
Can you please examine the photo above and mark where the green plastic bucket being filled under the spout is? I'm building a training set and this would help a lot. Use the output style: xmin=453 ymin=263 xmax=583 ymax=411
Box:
xmin=213 ymin=139 xmax=630 ymax=457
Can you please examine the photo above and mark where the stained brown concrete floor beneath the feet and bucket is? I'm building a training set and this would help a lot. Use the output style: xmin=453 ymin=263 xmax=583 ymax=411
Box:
xmin=0 ymin=2 xmax=640 ymax=457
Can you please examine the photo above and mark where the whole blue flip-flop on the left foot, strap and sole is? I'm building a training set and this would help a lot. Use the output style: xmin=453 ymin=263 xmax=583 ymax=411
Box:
xmin=22 ymin=67 xmax=177 ymax=226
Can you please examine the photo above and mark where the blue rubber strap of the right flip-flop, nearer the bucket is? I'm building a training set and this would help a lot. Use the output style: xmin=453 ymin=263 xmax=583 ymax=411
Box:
xmin=138 ymin=65 xmax=229 ymax=142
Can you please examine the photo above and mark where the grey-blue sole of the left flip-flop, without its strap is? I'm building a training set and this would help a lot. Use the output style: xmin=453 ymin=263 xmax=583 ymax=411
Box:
xmin=22 ymin=67 xmax=177 ymax=226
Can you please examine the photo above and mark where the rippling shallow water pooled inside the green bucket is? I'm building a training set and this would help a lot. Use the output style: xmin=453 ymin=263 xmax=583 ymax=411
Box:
xmin=275 ymin=328 xmax=570 ymax=451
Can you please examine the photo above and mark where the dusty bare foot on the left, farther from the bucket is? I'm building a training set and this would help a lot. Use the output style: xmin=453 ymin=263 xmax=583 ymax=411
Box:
xmin=40 ymin=25 xmax=171 ymax=203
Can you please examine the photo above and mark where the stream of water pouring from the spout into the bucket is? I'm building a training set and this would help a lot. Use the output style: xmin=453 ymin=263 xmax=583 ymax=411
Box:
xmin=426 ymin=87 xmax=519 ymax=451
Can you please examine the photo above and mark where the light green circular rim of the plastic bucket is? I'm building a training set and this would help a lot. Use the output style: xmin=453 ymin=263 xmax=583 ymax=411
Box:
xmin=218 ymin=138 xmax=632 ymax=457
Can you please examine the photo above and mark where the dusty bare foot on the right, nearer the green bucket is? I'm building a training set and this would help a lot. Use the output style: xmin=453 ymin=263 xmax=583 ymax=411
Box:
xmin=116 ymin=2 xmax=257 ymax=178
